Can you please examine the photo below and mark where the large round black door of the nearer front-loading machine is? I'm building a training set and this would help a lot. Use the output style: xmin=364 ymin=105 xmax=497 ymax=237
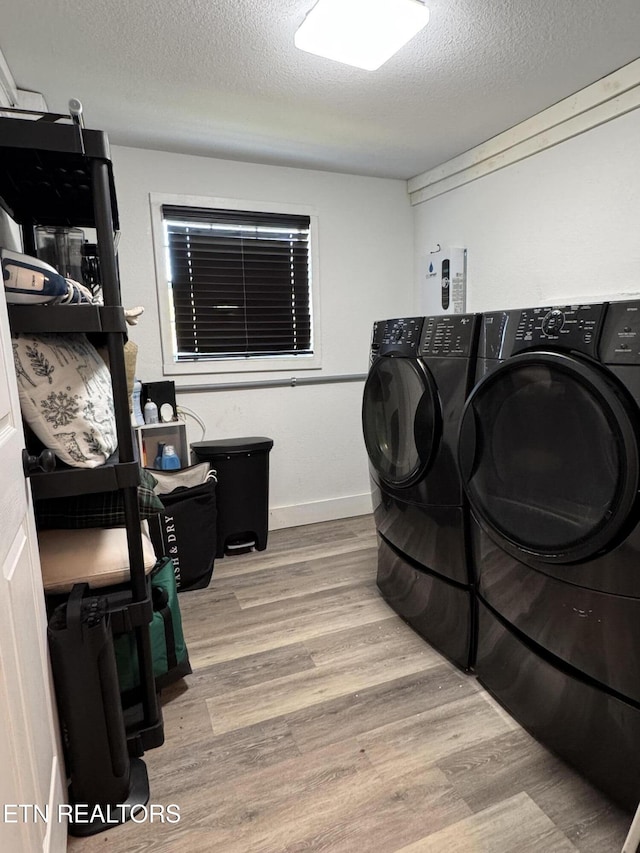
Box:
xmin=459 ymin=352 xmax=638 ymax=563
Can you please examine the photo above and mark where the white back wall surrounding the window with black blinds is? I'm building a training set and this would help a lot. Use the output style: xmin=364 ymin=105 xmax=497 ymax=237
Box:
xmin=112 ymin=147 xmax=414 ymax=529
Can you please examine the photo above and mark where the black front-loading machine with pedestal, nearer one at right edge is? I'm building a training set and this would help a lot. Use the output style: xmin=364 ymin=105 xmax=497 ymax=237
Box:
xmin=459 ymin=301 xmax=640 ymax=809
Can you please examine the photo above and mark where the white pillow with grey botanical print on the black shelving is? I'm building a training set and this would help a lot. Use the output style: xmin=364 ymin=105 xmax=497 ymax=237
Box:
xmin=12 ymin=334 xmax=118 ymax=468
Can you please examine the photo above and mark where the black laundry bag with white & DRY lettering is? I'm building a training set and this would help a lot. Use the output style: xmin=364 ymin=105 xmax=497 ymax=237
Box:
xmin=148 ymin=469 xmax=217 ymax=592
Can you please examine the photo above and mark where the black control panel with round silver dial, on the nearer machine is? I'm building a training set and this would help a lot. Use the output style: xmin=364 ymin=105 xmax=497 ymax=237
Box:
xmin=507 ymin=303 xmax=605 ymax=356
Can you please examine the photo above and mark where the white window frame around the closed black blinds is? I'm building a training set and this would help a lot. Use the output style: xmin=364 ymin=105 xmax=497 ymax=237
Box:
xmin=149 ymin=193 xmax=322 ymax=376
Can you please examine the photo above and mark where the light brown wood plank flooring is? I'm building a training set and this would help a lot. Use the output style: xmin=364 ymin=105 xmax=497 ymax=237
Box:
xmin=68 ymin=516 xmax=631 ymax=853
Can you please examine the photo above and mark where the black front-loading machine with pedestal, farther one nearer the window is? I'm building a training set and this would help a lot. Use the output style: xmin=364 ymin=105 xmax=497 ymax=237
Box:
xmin=362 ymin=315 xmax=480 ymax=669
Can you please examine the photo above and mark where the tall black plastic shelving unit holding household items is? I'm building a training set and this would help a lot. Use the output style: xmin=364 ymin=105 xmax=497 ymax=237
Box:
xmin=0 ymin=110 xmax=164 ymax=772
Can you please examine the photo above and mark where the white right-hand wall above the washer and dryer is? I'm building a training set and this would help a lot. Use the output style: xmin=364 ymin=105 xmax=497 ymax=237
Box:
xmin=413 ymin=109 xmax=640 ymax=311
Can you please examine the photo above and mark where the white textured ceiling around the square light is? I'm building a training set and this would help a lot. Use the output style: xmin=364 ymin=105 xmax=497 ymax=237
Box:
xmin=0 ymin=0 xmax=640 ymax=178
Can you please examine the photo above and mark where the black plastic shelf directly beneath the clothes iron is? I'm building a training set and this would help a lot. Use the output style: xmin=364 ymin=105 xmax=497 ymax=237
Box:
xmin=7 ymin=303 xmax=127 ymax=333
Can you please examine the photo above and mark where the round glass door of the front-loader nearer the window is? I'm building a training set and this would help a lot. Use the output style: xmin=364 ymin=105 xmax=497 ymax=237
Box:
xmin=362 ymin=356 xmax=441 ymax=488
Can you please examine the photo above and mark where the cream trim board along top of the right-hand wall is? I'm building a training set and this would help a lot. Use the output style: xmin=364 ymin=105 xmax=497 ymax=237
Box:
xmin=407 ymin=59 xmax=640 ymax=205
